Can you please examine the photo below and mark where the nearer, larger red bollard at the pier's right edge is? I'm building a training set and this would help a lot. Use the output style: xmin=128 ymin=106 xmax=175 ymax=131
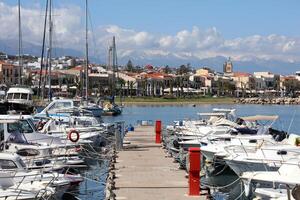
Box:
xmin=189 ymin=147 xmax=201 ymax=196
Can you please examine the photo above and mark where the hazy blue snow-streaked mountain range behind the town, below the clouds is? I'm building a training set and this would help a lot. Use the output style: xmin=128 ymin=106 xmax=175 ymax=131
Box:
xmin=0 ymin=40 xmax=300 ymax=75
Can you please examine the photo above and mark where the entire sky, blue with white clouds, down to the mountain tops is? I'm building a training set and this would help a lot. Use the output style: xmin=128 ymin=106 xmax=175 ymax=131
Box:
xmin=0 ymin=0 xmax=300 ymax=67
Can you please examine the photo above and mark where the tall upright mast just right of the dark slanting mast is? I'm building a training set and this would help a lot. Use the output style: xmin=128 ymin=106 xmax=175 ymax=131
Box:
xmin=48 ymin=0 xmax=53 ymax=101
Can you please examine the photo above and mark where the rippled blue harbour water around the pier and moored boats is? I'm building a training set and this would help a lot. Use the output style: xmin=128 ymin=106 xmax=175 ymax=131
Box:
xmin=73 ymin=104 xmax=300 ymax=199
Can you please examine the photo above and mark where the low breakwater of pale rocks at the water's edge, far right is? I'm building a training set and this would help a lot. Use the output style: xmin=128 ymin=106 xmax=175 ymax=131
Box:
xmin=234 ymin=97 xmax=300 ymax=105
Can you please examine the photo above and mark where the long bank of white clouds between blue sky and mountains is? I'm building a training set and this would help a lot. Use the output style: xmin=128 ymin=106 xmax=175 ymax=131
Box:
xmin=0 ymin=2 xmax=300 ymax=61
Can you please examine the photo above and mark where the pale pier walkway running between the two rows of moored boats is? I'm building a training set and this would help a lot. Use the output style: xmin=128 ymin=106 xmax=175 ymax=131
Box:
xmin=114 ymin=126 xmax=205 ymax=200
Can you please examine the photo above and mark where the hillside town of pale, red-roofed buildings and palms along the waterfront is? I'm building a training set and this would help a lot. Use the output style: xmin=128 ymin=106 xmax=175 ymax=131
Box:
xmin=0 ymin=53 xmax=300 ymax=98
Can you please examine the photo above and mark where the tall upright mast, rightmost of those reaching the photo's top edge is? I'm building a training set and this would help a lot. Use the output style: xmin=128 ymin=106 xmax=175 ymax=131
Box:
xmin=85 ymin=0 xmax=89 ymax=100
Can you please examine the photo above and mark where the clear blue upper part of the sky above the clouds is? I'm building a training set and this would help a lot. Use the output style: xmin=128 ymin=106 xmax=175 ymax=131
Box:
xmin=3 ymin=0 xmax=300 ymax=39
